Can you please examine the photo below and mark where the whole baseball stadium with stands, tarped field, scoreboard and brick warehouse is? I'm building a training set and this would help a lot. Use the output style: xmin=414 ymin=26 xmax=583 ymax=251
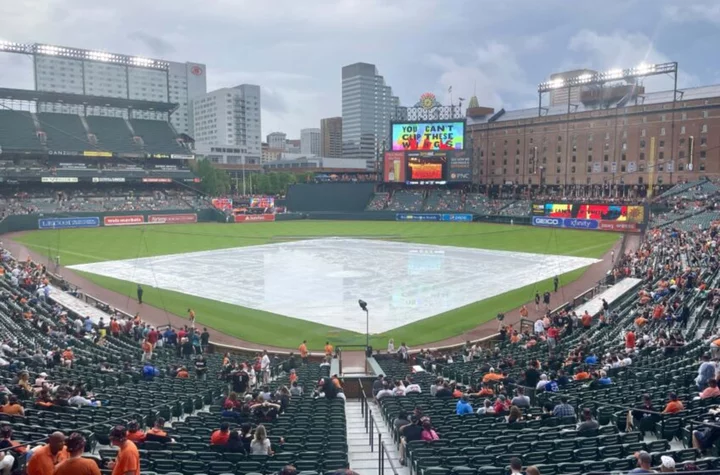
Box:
xmin=0 ymin=43 xmax=720 ymax=475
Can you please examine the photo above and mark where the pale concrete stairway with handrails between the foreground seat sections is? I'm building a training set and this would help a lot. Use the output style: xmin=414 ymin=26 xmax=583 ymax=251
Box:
xmin=345 ymin=400 xmax=410 ymax=475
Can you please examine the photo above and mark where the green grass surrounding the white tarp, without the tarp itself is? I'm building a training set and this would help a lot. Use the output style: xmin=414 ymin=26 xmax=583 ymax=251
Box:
xmin=17 ymin=221 xmax=619 ymax=349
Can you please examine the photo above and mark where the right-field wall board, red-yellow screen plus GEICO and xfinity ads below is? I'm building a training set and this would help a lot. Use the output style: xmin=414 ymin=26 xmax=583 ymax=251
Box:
xmin=532 ymin=203 xmax=648 ymax=232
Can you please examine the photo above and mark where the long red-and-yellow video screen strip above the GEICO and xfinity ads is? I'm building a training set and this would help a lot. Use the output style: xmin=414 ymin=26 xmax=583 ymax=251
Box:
xmin=532 ymin=203 xmax=646 ymax=223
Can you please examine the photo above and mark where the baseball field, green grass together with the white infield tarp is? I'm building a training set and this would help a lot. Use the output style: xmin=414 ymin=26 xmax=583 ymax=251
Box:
xmin=17 ymin=221 xmax=620 ymax=349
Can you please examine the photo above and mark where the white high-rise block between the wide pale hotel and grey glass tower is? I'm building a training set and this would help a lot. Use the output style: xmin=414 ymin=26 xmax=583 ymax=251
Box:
xmin=192 ymin=84 xmax=262 ymax=159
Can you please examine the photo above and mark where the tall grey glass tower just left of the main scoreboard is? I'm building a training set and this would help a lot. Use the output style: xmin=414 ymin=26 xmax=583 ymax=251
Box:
xmin=342 ymin=63 xmax=400 ymax=169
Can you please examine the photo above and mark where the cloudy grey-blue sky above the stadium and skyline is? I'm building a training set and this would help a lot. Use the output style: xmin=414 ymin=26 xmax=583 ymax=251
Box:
xmin=0 ymin=0 xmax=720 ymax=138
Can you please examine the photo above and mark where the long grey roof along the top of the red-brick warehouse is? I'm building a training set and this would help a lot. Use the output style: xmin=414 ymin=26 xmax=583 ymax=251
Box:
xmin=467 ymin=84 xmax=720 ymax=125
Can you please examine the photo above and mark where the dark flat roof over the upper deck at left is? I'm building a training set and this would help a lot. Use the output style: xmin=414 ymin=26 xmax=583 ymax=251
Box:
xmin=0 ymin=88 xmax=178 ymax=112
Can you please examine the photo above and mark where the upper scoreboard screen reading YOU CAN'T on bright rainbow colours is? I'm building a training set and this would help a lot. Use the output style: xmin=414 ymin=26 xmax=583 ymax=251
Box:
xmin=392 ymin=121 xmax=465 ymax=151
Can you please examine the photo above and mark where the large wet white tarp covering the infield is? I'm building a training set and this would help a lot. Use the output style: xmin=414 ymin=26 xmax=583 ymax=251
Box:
xmin=71 ymin=238 xmax=597 ymax=334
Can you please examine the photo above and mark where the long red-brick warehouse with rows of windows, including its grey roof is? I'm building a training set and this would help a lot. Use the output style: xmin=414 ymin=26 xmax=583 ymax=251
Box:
xmin=467 ymin=86 xmax=720 ymax=185
